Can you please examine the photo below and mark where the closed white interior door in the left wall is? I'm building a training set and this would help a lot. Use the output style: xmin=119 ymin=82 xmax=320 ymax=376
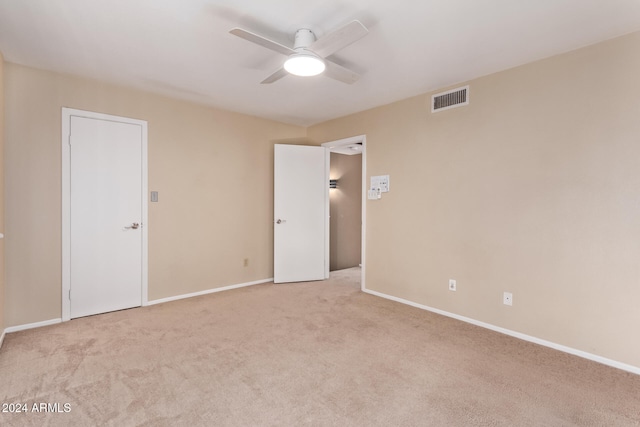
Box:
xmin=63 ymin=115 xmax=146 ymax=318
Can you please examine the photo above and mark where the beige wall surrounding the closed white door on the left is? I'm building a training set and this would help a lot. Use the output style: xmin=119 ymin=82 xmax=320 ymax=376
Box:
xmin=5 ymin=63 xmax=306 ymax=326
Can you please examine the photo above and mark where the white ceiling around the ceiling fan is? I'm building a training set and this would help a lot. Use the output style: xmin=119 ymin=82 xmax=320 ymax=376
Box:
xmin=0 ymin=0 xmax=640 ymax=126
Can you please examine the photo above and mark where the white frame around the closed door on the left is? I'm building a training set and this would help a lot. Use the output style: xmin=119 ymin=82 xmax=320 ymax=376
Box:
xmin=60 ymin=107 xmax=149 ymax=322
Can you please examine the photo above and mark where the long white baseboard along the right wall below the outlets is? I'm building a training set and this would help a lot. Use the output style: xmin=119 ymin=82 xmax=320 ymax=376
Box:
xmin=363 ymin=289 xmax=640 ymax=375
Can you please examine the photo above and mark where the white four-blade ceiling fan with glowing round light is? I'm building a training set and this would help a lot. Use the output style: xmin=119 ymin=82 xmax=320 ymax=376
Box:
xmin=229 ymin=21 xmax=369 ymax=84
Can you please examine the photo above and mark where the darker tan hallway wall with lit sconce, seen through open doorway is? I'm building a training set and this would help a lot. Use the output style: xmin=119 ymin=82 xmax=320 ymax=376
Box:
xmin=329 ymin=153 xmax=362 ymax=271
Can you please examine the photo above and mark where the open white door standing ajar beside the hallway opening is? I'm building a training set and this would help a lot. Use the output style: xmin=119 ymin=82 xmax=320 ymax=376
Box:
xmin=273 ymin=144 xmax=329 ymax=283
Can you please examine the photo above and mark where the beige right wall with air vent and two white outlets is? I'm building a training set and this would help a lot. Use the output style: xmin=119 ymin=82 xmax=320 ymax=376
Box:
xmin=308 ymin=33 xmax=640 ymax=367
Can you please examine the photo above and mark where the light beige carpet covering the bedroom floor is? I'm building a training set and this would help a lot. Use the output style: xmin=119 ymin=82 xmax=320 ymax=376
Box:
xmin=0 ymin=269 xmax=640 ymax=426
